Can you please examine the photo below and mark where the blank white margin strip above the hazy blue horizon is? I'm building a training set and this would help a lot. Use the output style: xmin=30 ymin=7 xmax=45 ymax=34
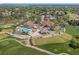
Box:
xmin=0 ymin=0 xmax=79 ymax=3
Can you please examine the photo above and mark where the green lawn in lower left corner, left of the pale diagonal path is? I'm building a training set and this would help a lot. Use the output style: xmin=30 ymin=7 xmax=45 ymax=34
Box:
xmin=0 ymin=37 xmax=46 ymax=55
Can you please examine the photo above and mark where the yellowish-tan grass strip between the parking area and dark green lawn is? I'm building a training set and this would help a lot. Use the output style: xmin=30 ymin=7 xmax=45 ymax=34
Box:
xmin=32 ymin=33 xmax=72 ymax=45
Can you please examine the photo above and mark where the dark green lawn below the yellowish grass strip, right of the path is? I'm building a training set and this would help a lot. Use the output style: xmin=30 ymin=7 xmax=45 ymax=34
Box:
xmin=38 ymin=43 xmax=79 ymax=55
